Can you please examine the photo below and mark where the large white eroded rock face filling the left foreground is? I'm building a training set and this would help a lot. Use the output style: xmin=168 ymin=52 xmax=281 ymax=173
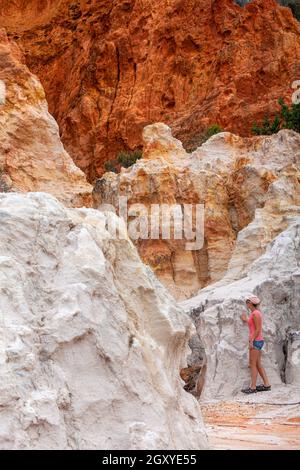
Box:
xmin=0 ymin=193 xmax=206 ymax=449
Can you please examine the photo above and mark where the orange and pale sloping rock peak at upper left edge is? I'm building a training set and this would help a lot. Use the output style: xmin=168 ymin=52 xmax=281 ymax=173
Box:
xmin=0 ymin=30 xmax=91 ymax=206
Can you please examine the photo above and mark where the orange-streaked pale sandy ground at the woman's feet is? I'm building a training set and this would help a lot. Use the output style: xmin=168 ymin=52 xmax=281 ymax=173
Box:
xmin=201 ymin=386 xmax=300 ymax=450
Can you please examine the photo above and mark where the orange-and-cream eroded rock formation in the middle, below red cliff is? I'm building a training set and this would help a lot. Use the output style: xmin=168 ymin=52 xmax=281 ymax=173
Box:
xmin=94 ymin=123 xmax=300 ymax=299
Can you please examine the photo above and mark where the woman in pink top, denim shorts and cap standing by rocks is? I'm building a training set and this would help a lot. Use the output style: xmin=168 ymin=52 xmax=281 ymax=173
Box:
xmin=241 ymin=296 xmax=271 ymax=395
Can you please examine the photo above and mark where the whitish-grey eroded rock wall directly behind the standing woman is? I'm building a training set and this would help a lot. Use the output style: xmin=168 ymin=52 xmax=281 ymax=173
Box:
xmin=182 ymin=218 xmax=300 ymax=402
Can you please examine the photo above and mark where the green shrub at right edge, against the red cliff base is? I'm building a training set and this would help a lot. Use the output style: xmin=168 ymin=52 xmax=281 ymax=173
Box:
xmin=252 ymin=98 xmax=300 ymax=135
